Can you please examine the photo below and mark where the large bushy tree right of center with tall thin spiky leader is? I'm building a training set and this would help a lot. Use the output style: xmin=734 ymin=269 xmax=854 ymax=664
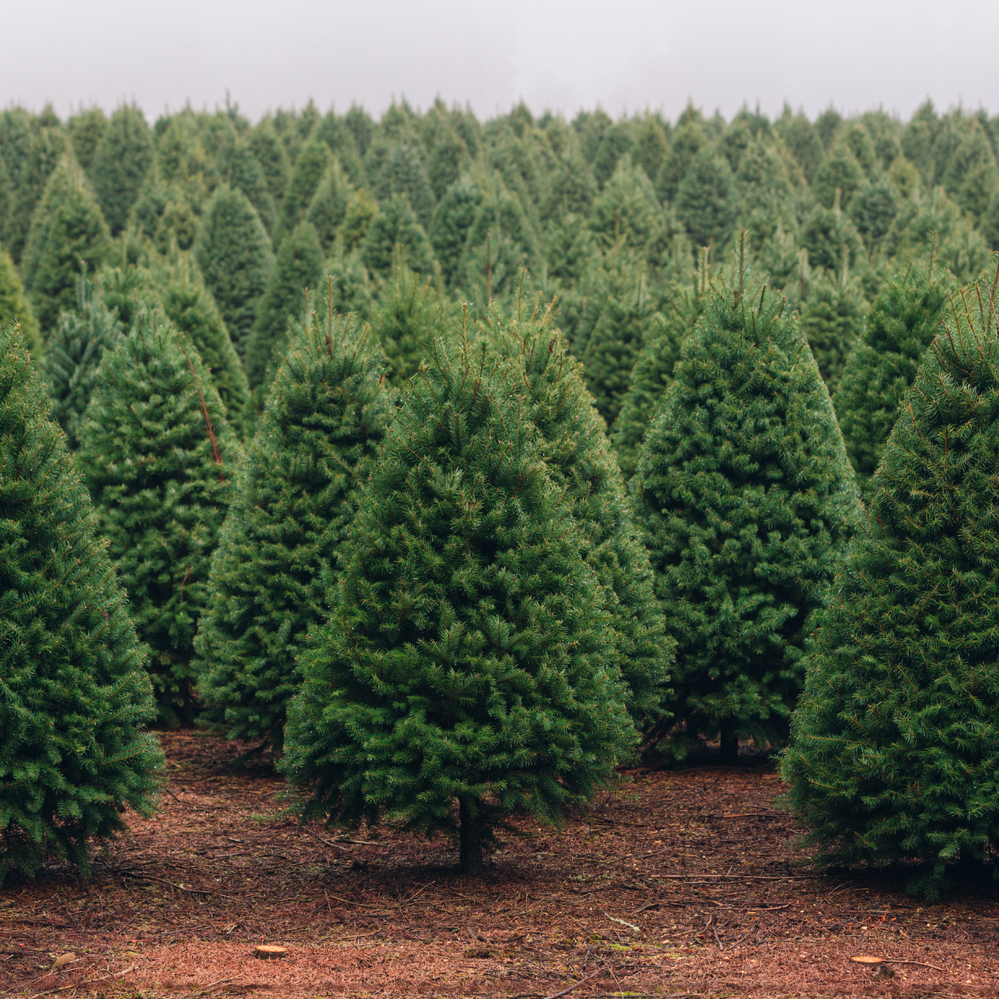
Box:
xmin=633 ymin=246 xmax=860 ymax=761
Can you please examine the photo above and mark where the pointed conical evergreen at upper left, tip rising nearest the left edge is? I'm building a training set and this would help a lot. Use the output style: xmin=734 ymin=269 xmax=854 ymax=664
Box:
xmin=24 ymin=161 xmax=112 ymax=330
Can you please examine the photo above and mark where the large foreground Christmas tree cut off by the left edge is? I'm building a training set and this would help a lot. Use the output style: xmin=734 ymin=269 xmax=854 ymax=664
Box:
xmin=0 ymin=325 xmax=163 ymax=883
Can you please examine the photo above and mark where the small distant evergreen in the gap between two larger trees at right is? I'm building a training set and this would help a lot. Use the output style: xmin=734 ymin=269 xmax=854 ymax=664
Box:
xmin=801 ymin=262 xmax=866 ymax=395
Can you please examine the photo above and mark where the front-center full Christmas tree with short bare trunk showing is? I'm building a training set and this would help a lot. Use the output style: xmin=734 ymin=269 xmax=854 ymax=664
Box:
xmin=284 ymin=334 xmax=635 ymax=873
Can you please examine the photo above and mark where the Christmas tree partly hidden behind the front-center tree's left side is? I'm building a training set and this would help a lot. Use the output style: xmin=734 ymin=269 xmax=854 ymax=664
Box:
xmin=195 ymin=292 xmax=392 ymax=749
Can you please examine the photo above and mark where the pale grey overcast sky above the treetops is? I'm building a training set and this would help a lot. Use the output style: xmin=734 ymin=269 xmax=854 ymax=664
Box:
xmin=0 ymin=0 xmax=999 ymax=120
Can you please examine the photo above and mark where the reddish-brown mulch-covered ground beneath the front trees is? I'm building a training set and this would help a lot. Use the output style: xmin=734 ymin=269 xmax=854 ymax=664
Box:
xmin=0 ymin=732 xmax=999 ymax=999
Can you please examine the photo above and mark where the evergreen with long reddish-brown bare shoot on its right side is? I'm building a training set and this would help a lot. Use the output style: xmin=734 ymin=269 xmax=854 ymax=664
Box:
xmin=76 ymin=313 xmax=239 ymax=724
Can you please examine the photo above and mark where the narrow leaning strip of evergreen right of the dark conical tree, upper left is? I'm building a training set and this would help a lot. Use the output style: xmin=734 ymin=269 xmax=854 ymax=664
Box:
xmin=246 ymin=221 xmax=323 ymax=386
